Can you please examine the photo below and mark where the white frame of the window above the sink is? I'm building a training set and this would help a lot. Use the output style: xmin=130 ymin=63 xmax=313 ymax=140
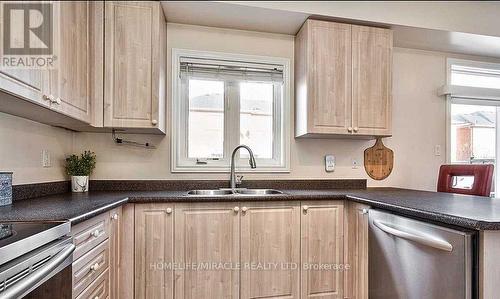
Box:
xmin=171 ymin=48 xmax=291 ymax=172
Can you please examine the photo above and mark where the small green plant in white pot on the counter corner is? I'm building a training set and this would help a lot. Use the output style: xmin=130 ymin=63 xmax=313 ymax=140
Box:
xmin=66 ymin=151 xmax=96 ymax=192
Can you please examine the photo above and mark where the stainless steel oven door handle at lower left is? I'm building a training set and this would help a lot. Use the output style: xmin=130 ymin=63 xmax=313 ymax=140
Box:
xmin=0 ymin=244 xmax=75 ymax=299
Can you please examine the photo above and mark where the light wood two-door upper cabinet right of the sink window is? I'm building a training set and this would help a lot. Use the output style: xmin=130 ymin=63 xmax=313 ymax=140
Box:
xmin=295 ymin=20 xmax=392 ymax=137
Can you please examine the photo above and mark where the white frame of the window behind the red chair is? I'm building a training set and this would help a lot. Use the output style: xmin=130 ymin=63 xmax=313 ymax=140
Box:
xmin=444 ymin=58 xmax=500 ymax=194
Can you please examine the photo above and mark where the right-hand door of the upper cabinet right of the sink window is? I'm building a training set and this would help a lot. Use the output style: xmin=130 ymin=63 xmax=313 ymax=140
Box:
xmin=352 ymin=25 xmax=392 ymax=135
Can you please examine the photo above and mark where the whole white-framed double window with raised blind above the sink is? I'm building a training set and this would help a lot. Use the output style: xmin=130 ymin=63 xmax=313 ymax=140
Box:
xmin=172 ymin=49 xmax=290 ymax=172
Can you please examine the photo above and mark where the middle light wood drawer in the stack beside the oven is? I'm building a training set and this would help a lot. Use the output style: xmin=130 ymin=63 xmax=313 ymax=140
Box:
xmin=72 ymin=240 xmax=109 ymax=298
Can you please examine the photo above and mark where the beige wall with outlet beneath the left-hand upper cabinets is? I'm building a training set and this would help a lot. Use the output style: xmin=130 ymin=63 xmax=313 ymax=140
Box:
xmin=0 ymin=112 xmax=73 ymax=185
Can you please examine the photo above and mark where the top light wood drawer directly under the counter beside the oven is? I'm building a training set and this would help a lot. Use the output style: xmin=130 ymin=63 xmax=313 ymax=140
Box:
xmin=71 ymin=213 xmax=109 ymax=260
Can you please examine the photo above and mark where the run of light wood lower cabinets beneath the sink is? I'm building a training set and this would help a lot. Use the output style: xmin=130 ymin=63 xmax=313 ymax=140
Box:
xmin=131 ymin=200 xmax=368 ymax=299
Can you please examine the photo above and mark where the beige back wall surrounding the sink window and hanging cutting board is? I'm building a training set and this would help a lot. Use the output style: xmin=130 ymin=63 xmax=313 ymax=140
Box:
xmin=75 ymin=23 xmax=454 ymax=190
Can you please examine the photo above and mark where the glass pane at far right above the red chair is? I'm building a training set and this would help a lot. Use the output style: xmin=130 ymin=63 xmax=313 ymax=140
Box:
xmin=450 ymin=104 xmax=496 ymax=164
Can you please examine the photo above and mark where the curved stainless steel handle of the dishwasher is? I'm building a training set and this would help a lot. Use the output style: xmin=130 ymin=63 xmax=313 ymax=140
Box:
xmin=373 ymin=220 xmax=453 ymax=252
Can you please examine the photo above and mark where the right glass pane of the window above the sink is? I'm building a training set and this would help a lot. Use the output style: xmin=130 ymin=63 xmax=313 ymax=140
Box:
xmin=240 ymin=82 xmax=274 ymax=159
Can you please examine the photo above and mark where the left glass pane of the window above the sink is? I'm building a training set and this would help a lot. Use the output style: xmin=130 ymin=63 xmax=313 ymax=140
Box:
xmin=188 ymin=79 xmax=224 ymax=158
